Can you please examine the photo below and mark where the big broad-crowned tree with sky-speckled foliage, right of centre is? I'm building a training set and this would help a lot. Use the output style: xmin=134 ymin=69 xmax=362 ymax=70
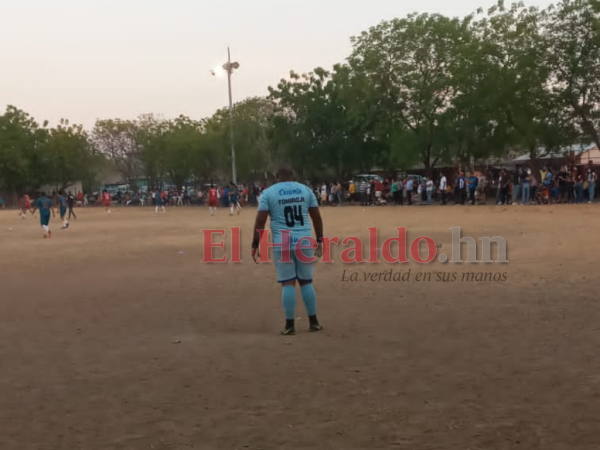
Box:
xmin=349 ymin=14 xmax=470 ymax=173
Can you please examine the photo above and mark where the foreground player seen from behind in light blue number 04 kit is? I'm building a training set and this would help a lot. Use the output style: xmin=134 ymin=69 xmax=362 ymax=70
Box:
xmin=252 ymin=165 xmax=323 ymax=335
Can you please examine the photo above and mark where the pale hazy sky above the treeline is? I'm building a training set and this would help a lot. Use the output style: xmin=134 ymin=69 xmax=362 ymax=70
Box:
xmin=0 ymin=0 xmax=551 ymax=128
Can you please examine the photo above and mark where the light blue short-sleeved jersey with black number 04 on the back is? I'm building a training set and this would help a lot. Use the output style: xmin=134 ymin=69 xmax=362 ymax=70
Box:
xmin=258 ymin=181 xmax=319 ymax=244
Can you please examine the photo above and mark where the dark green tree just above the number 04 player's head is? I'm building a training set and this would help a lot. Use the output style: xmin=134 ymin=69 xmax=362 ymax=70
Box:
xmin=269 ymin=65 xmax=381 ymax=179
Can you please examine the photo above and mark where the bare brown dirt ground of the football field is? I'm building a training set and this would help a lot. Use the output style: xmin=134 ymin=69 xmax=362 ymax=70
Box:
xmin=0 ymin=205 xmax=600 ymax=450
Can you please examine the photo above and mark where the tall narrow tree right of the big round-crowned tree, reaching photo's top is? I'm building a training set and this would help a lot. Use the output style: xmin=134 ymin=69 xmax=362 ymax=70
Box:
xmin=476 ymin=1 xmax=572 ymax=159
